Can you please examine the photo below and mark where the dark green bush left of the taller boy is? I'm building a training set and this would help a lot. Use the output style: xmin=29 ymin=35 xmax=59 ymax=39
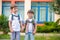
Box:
xmin=0 ymin=15 xmax=8 ymax=34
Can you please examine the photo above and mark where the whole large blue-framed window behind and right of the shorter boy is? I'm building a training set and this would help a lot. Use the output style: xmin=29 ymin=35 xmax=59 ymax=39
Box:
xmin=31 ymin=2 xmax=54 ymax=23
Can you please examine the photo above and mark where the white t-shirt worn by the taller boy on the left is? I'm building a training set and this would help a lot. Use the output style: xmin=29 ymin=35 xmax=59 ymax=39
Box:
xmin=9 ymin=13 xmax=22 ymax=31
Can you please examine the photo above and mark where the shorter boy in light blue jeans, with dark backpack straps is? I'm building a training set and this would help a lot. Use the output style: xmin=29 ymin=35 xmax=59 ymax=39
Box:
xmin=25 ymin=10 xmax=37 ymax=40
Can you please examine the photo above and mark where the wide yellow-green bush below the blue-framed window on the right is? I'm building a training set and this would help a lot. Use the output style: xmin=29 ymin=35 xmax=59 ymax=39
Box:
xmin=37 ymin=22 xmax=60 ymax=33
